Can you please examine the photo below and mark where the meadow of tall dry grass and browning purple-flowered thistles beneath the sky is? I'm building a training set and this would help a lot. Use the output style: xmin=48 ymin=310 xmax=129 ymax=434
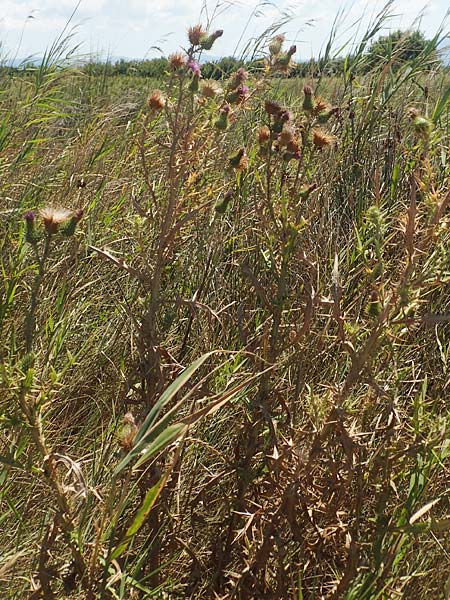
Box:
xmin=0 ymin=17 xmax=450 ymax=600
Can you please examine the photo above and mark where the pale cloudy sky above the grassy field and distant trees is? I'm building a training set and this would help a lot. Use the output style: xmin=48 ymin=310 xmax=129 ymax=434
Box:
xmin=0 ymin=0 xmax=450 ymax=60
